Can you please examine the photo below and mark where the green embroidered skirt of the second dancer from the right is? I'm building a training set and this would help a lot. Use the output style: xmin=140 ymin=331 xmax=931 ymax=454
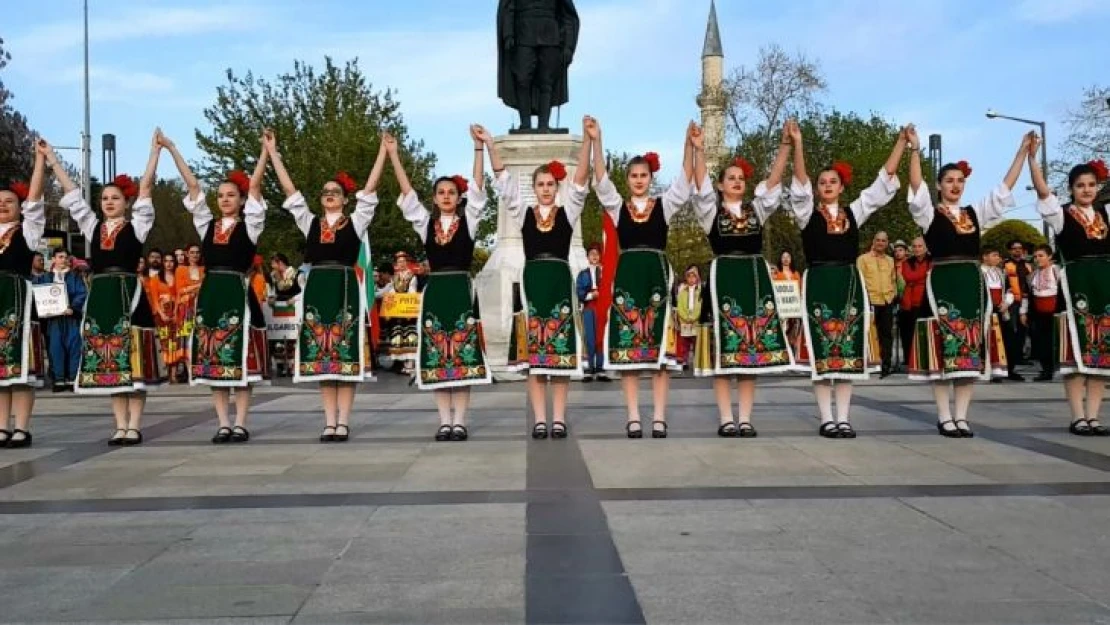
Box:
xmin=909 ymin=260 xmax=1006 ymax=381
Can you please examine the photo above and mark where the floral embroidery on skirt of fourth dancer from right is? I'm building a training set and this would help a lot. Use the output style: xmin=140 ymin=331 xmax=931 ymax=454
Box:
xmin=718 ymin=294 xmax=790 ymax=369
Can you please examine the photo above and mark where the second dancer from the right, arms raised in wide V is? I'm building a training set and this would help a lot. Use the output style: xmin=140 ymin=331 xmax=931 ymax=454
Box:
xmin=907 ymin=125 xmax=1036 ymax=438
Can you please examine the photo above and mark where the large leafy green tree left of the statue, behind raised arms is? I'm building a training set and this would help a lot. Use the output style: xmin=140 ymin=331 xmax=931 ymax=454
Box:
xmin=196 ymin=58 xmax=435 ymax=261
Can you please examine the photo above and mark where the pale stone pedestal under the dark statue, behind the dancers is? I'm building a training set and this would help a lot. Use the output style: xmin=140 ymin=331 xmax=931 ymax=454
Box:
xmin=474 ymin=134 xmax=588 ymax=382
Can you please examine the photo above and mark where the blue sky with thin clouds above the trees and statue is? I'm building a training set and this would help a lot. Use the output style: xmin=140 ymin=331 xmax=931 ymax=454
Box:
xmin=0 ymin=0 xmax=1110 ymax=225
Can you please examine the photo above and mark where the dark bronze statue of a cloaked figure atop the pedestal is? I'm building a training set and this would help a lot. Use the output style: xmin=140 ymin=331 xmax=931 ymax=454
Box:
xmin=497 ymin=0 xmax=578 ymax=133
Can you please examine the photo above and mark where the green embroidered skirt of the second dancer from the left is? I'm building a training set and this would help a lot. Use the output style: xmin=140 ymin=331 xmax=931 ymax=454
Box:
xmin=74 ymin=272 xmax=167 ymax=395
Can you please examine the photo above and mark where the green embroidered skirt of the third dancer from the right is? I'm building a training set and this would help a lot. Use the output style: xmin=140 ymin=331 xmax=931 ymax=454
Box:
xmin=801 ymin=264 xmax=879 ymax=381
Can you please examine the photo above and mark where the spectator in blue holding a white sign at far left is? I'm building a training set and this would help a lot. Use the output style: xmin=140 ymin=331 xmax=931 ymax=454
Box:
xmin=38 ymin=249 xmax=88 ymax=393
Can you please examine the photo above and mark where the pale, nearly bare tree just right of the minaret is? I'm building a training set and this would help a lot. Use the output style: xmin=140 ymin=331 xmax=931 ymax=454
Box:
xmin=722 ymin=43 xmax=828 ymax=171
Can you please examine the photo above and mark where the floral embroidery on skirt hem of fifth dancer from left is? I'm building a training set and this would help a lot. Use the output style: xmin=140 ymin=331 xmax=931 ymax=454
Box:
xmin=420 ymin=313 xmax=486 ymax=384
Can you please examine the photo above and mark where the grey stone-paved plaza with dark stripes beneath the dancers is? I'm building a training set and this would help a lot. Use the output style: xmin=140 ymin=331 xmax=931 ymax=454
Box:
xmin=0 ymin=374 xmax=1110 ymax=625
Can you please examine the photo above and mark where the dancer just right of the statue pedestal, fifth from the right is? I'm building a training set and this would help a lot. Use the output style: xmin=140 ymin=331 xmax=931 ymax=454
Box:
xmin=586 ymin=118 xmax=694 ymax=438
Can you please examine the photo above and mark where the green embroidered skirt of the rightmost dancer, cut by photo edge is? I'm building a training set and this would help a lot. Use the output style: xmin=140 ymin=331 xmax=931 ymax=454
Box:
xmin=1057 ymin=256 xmax=1110 ymax=376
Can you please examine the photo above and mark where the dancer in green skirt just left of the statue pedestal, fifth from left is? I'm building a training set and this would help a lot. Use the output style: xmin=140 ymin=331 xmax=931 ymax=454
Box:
xmin=382 ymin=128 xmax=492 ymax=441
